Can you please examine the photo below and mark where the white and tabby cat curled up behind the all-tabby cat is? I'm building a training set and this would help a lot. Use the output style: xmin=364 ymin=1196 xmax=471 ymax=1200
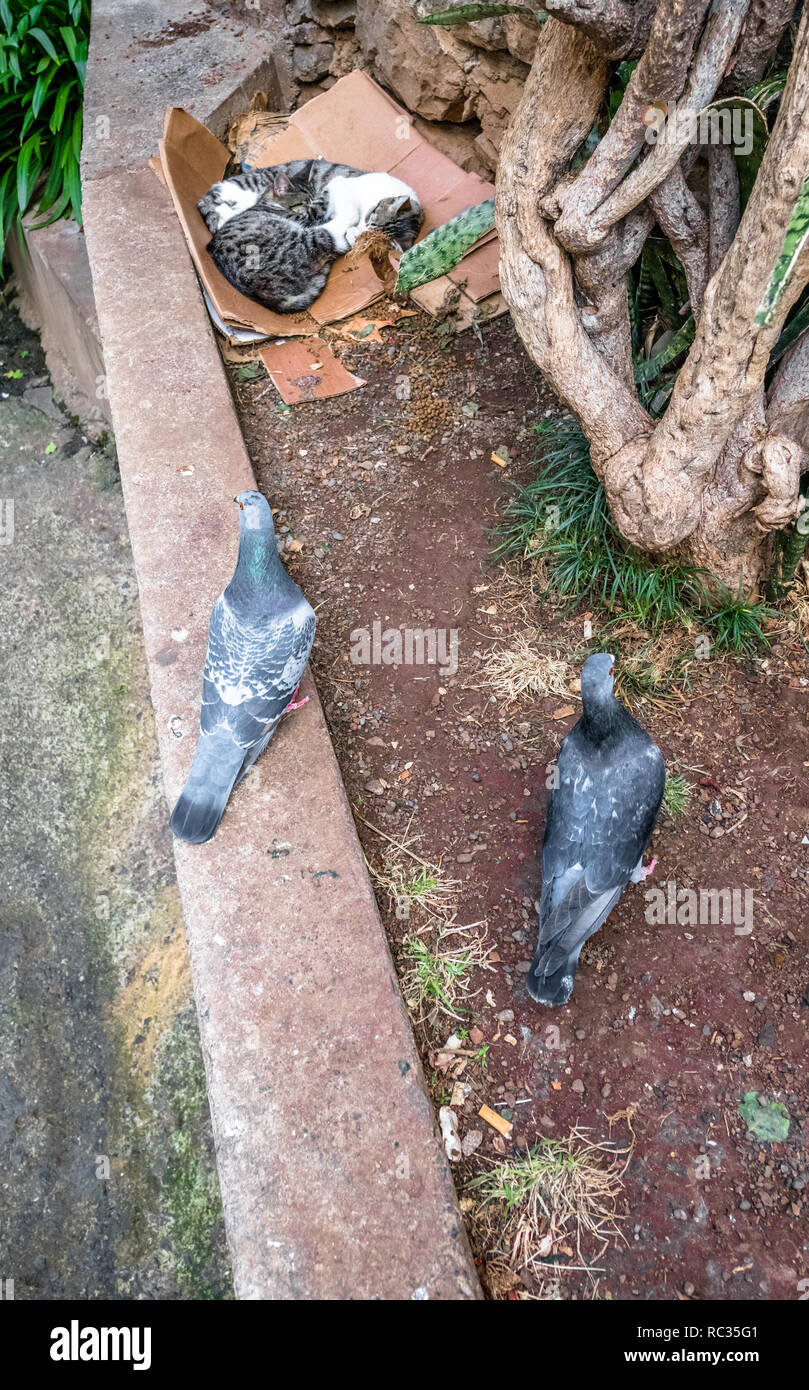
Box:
xmin=197 ymin=160 xmax=424 ymax=252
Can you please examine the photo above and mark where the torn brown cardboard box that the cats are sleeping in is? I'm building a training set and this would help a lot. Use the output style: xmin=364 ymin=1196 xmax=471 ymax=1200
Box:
xmin=160 ymin=71 xmax=499 ymax=346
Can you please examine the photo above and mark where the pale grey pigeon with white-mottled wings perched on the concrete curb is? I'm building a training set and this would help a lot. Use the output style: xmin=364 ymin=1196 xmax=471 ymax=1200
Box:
xmin=170 ymin=492 xmax=316 ymax=845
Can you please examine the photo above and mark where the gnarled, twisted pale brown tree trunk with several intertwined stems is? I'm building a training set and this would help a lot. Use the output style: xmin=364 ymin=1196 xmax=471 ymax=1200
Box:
xmin=496 ymin=0 xmax=809 ymax=594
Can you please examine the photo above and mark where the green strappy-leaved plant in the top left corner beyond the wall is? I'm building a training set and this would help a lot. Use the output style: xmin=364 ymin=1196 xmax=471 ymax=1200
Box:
xmin=0 ymin=0 xmax=90 ymax=245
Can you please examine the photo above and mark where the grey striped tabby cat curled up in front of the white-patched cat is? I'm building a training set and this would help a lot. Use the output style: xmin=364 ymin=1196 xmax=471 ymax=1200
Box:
xmin=207 ymin=204 xmax=339 ymax=314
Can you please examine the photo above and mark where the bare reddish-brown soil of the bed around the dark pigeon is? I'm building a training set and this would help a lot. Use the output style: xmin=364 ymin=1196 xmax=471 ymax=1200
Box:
xmin=234 ymin=309 xmax=809 ymax=1300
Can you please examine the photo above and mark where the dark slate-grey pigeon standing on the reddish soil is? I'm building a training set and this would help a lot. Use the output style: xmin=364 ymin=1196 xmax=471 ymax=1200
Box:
xmin=527 ymin=652 xmax=666 ymax=1006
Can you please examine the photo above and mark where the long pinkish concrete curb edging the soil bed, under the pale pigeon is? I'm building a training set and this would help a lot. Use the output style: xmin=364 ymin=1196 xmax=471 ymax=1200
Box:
xmin=85 ymin=0 xmax=482 ymax=1300
